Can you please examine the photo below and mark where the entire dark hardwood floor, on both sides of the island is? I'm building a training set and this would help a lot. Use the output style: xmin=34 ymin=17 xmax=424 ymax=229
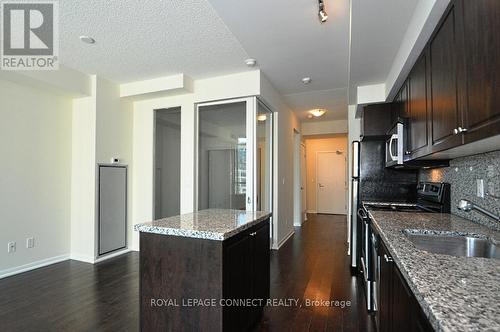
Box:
xmin=0 ymin=215 xmax=374 ymax=332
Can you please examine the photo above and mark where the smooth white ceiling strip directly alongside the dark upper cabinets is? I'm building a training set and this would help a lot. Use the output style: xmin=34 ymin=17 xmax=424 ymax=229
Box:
xmin=349 ymin=0 xmax=419 ymax=104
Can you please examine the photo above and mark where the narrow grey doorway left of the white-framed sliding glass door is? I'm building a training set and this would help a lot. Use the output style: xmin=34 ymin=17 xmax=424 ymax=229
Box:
xmin=154 ymin=107 xmax=181 ymax=219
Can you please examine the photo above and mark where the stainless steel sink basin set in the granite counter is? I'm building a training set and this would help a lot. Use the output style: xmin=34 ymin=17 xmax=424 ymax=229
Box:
xmin=404 ymin=231 xmax=500 ymax=259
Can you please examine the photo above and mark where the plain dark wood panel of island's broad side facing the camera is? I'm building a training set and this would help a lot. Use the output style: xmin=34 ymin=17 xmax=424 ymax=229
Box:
xmin=140 ymin=232 xmax=222 ymax=332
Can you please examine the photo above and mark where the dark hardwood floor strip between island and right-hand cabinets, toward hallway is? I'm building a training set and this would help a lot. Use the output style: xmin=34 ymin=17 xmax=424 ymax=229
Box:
xmin=256 ymin=214 xmax=375 ymax=331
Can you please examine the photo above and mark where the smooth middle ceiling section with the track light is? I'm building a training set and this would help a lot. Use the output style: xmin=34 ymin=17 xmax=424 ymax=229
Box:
xmin=208 ymin=0 xmax=349 ymax=119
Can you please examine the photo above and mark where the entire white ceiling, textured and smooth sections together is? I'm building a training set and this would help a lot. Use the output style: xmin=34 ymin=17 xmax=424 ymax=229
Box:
xmin=55 ymin=0 xmax=418 ymax=120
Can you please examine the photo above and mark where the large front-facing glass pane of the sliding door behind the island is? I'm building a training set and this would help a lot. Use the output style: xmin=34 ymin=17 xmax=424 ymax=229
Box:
xmin=198 ymin=102 xmax=247 ymax=210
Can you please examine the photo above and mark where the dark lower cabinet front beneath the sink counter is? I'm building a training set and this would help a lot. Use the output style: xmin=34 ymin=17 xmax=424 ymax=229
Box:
xmin=378 ymin=242 xmax=434 ymax=332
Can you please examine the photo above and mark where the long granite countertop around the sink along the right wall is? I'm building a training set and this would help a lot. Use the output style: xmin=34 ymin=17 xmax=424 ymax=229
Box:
xmin=369 ymin=210 xmax=500 ymax=331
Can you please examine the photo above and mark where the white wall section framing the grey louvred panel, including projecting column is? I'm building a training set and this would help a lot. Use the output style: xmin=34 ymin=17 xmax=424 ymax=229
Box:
xmin=71 ymin=76 xmax=133 ymax=262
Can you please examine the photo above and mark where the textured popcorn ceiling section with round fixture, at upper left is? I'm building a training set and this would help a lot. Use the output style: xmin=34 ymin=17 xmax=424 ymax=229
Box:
xmin=59 ymin=0 xmax=248 ymax=83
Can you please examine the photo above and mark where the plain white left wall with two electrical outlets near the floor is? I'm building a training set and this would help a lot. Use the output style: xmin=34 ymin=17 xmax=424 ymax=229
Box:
xmin=0 ymin=80 xmax=72 ymax=276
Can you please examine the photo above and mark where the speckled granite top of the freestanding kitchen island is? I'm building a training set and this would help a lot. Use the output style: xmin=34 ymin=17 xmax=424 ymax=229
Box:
xmin=134 ymin=209 xmax=271 ymax=241
